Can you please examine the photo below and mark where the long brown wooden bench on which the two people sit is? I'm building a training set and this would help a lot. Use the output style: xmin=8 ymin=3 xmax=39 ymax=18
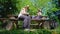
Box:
xmin=0 ymin=15 xmax=49 ymax=28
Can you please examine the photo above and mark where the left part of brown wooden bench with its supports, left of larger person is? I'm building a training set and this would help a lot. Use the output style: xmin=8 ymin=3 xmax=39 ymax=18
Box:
xmin=0 ymin=17 xmax=17 ymax=30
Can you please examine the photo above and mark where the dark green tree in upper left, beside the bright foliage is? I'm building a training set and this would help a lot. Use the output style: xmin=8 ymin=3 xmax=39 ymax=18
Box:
xmin=0 ymin=0 xmax=17 ymax=17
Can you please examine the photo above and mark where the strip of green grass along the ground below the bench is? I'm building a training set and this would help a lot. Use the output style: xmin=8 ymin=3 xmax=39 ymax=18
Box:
xmin=0 ymin=29 xmax=60 ymax=34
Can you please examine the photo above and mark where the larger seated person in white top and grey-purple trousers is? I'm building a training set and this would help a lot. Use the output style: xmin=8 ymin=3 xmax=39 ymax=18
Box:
xmin=18 ymin=5 xmax=31 ymax=29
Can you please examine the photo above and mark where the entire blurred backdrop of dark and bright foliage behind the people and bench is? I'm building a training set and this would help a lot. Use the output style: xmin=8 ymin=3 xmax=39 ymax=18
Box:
xmin=0 ymin=0 xmax=60 ymax=33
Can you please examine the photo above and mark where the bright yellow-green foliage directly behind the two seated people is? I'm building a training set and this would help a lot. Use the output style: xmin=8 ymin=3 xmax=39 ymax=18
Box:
xmin=16 ymin=0 xmax=52 ymax=15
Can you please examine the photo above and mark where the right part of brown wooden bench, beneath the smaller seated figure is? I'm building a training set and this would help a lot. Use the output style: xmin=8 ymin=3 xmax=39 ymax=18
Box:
xmin=32 ymin=16 xmax=49 ymax=28
